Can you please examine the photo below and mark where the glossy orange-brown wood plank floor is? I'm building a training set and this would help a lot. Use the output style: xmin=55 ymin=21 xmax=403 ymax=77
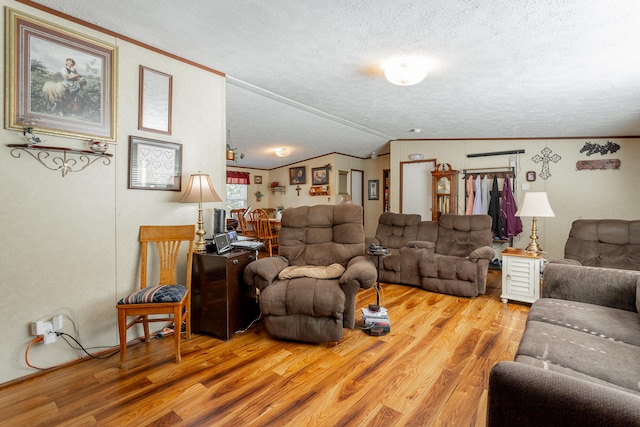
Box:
xmin=0 ymin=271 xmax=529 ymax=426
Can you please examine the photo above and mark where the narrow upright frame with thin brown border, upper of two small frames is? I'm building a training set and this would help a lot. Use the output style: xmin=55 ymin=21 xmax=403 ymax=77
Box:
xmin=138 ymin=65 xmax=173 ymax=135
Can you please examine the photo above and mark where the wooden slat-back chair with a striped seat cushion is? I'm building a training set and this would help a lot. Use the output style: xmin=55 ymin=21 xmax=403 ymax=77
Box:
xmin=117 ymin=225 xmax=196 ymax=367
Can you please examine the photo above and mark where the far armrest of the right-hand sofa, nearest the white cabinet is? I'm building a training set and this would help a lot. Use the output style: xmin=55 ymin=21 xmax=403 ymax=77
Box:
xmin=541 ymin=263 xmax=640 ymax=311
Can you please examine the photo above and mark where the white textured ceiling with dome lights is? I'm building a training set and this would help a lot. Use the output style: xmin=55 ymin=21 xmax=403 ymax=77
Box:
xmin=35 ymin=0 xmax=640 ymax=168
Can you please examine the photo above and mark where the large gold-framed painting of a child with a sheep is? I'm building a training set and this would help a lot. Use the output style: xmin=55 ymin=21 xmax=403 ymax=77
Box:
xmin=5 ymin=8 xmax=117 ymax=143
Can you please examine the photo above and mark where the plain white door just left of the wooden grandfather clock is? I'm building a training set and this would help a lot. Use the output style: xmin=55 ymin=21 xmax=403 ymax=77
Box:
xmin=400 ymin=159 xmax=436 ymax=221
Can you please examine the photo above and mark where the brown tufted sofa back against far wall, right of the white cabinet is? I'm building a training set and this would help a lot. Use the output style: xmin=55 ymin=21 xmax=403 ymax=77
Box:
xmin=563 ymin=219 xmax=640 ymax=270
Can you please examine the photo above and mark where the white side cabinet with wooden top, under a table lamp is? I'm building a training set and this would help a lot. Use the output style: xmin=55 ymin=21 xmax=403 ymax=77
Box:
xmin=500 ymin=248 xmax=542 ymax=303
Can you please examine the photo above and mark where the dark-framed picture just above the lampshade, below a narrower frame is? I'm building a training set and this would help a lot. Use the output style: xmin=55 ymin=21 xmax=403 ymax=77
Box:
xmin=128 ymin=136 xmax=182 ymax=191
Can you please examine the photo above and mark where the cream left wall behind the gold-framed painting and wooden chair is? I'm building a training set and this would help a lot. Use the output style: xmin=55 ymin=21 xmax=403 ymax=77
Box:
xmin=0 ymin=0 xmax=225 ymax=383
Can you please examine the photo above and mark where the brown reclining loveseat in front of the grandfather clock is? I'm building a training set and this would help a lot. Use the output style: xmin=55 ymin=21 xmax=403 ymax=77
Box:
xmin=367 ymin=212 xmax=495 ymax=297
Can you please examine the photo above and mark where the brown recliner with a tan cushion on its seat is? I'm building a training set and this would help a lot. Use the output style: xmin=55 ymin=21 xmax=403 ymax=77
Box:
xmin=244 ymin=204 xmax=376 ymax=343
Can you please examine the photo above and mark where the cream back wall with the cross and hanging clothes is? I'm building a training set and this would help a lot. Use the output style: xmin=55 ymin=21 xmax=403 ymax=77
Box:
xmin=391 ymin=138 xmax=640 ymax=259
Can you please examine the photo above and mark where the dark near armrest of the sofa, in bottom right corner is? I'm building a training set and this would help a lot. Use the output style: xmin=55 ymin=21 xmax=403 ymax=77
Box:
xmin=487 ymin=362 xmax=640 ymax=427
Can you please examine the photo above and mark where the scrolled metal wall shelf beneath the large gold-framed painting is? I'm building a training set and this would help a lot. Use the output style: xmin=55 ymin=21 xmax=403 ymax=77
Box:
xmin=7 ymin=144 xmax=113 ymax=177
